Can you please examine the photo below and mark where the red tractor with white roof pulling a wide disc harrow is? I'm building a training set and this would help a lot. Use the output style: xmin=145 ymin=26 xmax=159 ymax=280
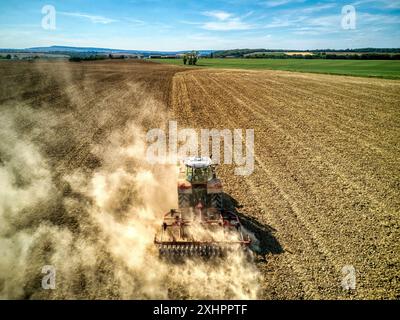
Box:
xmin=154 ymin=157 xmax=251 ymax=258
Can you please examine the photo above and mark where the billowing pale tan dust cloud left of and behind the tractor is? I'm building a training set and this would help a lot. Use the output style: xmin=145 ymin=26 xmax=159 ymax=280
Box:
xmin=0 ymin=60 xmax=259 ymax=299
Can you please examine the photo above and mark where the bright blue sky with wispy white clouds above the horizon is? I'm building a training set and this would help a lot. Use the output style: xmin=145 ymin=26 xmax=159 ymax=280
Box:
xmin=0 ymin=0 xmax=400 ymax=50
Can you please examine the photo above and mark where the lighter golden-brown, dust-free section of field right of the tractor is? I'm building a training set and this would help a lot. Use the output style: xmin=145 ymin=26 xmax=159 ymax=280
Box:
xmin=172 ymin=70 xmax=400 ymax=299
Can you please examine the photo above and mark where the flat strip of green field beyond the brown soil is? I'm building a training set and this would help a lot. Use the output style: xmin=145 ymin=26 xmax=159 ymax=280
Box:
xmin=152 ymin=59 xmax=400 ymax=79
